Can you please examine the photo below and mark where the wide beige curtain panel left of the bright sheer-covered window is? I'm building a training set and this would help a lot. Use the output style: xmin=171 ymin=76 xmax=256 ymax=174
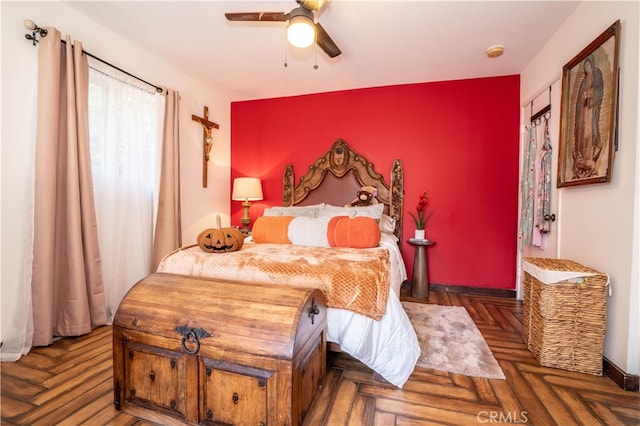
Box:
xmin=31 ymin=28 xmax=106 ymax=346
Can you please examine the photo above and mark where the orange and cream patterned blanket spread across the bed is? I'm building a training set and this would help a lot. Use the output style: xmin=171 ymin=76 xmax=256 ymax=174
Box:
xmin=158 ymin=243 xmax=391 ymax=320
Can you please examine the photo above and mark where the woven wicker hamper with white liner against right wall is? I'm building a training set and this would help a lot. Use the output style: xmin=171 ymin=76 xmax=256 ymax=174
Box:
xmin=522 ymin=258 xmax=609 ymax=376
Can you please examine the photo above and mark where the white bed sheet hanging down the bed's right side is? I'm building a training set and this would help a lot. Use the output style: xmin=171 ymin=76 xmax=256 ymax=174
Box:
xmin=158 ymin=234 xmax=420 ymax=388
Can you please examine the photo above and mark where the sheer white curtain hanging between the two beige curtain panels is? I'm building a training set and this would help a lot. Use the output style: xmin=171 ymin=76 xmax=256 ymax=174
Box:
xmin=89 ymin=64 xmax=164 ymax=323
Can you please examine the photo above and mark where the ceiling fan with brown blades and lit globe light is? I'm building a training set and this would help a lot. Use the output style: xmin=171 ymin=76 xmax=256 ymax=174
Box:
xmin=224 ymin=0 xmax=342 ymax=58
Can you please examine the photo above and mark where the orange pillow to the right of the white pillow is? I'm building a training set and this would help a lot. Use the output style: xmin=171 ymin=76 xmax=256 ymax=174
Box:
xmin=327 ymin=216 xmax=380 ymax=248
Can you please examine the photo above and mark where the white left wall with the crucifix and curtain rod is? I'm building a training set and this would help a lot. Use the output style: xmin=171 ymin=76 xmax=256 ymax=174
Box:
xmin=0 ymin=1 xmax=231 ymax=359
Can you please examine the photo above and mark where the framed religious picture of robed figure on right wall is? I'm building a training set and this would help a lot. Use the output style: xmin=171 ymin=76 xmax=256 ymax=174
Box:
xmin=558 ymin=20 xmax=620 ymax=188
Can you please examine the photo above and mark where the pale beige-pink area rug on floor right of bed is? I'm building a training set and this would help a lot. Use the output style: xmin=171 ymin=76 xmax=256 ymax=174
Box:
xmin=402 ymin=302 xmax=505 ymax=379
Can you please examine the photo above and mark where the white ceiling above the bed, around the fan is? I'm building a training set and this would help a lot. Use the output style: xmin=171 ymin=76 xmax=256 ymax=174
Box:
xmin=68 ymin=0 xmax=579 ymax=101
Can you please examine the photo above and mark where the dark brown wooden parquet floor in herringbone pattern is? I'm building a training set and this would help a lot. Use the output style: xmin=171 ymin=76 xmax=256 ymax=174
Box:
xmin=0 ymin=292 xmax=640 ymax=426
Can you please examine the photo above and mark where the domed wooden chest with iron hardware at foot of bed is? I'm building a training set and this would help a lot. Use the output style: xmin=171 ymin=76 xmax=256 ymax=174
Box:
xmin=113 ymin=274 xmax=326 ymax=425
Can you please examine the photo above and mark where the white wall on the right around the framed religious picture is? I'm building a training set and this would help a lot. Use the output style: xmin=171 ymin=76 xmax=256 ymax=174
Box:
xmin=521 ymin=1 xmax=640 ymax=374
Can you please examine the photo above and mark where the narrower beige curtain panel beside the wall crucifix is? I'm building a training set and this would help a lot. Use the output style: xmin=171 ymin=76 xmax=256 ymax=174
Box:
xmin=151 ymin=89 xmax=182 ymax=272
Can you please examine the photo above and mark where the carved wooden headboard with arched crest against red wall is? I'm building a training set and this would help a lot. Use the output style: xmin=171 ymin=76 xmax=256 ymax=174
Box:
xmin=282 ymin=139 xmax=404 ymax=243
